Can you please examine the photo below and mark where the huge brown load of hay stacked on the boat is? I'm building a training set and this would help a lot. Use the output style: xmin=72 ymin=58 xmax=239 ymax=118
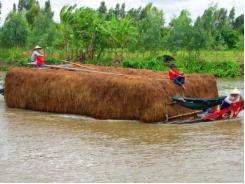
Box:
xmin=4 ymin=65 xmax=218 ymax=122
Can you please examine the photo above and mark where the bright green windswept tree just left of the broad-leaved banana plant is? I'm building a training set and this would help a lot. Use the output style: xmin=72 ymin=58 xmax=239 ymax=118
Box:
xmin=61 ymin=7 xmax=106 ymax=58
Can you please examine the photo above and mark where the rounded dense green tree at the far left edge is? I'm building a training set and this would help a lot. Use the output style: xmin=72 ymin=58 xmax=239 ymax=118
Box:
xmin=1 ymin=12 xmax=29 ymax=47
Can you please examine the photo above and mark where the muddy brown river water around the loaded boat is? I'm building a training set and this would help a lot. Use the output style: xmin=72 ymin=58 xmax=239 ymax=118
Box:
xmin=0 ymin=75 xmax=244 ymax=182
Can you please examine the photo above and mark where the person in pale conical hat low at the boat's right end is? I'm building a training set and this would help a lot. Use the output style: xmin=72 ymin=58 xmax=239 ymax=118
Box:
xmin=220 ymin=88 xmax=242 ymax=110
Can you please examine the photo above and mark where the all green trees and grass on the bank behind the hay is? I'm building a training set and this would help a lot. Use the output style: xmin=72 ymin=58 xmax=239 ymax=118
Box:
xmin=0 ymin=0 xmax=244 ymax=77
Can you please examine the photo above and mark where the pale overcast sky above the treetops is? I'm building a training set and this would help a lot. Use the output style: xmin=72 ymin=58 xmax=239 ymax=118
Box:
xmin=0 ymin=0 xmax=244 ymax=25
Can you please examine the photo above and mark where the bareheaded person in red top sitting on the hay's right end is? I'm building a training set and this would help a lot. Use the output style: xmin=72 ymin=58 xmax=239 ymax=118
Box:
xmin=168 ymin=64 xmax=185 ymax=89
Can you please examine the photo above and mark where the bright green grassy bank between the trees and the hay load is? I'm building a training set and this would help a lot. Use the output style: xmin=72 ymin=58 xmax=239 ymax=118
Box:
xmin=0 ymin=48 xmax=244 ymax=77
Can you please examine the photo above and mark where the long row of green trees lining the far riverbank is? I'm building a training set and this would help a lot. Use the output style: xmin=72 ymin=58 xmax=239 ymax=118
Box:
xmin=0 ymin=0 xmax=244 ymax=60
